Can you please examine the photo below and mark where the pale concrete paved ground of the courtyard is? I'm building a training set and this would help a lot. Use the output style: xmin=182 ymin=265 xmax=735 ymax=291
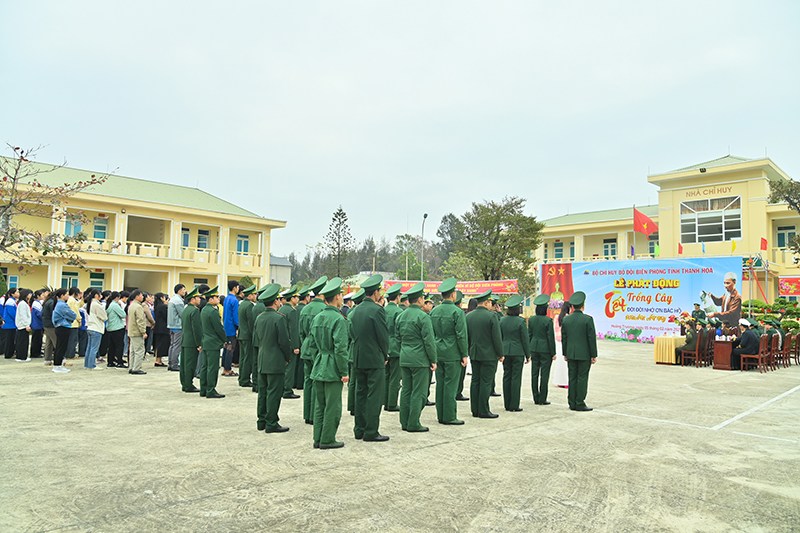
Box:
xmin=0 ymin=342 xmax=800 ymax=532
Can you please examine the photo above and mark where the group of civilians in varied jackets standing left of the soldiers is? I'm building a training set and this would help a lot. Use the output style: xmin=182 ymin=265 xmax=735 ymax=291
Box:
xmin=0 ymin=285 xmax=197 ymax=374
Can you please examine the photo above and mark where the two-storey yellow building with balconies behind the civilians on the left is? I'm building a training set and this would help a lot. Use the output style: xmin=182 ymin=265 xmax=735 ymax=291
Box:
xmin=0 ymin=164 xmax=286 ymax=294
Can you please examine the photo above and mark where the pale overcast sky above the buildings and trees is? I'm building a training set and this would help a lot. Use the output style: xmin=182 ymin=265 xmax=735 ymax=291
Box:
xmin=0 ymin=0 xmax=800 ymax=255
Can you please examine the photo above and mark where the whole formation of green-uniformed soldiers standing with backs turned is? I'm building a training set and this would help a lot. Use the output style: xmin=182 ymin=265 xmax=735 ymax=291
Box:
xmin=180 ymin=275 xmax=597 ymax=449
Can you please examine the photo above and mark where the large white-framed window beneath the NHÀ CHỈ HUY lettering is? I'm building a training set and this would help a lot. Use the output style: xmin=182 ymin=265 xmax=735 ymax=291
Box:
xmin=681 ymin=196 xmax=742 ymax=244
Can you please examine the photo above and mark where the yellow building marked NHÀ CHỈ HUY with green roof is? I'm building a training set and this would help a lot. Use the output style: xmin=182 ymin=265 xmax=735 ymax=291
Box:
xmin=535 ymin=155 xmax=800 ymax=300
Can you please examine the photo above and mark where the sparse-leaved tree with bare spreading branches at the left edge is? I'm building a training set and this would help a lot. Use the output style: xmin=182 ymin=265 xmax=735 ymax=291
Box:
xmin=0 ymin=144 xmax=113 ymax=268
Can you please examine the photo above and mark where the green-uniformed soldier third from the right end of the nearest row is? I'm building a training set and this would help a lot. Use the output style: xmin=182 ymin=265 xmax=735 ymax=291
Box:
xmin=500 ymin=294 xmax=530 ymax=412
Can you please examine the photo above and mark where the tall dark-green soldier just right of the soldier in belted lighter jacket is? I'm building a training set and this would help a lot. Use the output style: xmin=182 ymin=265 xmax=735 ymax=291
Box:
xmin=349 ymin=274 xmax=389 ymax=442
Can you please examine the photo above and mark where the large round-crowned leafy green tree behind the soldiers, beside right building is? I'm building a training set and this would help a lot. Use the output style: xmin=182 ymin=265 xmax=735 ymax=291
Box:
xmin=447 ymin=196 xmax=544 ymax=294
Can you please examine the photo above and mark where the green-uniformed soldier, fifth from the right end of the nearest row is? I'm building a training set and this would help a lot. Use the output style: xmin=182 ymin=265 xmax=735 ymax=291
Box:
xmin=431 ymin=278 xmax=469 ymax=425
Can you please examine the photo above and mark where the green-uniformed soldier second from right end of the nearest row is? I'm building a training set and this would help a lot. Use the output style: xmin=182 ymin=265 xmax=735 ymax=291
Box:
xmin=528 ymin=294 xmax=556 ymax=405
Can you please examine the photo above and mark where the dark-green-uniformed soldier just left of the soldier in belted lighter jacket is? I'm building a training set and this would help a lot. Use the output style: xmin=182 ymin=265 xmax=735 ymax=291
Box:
xmin=253 ymin=283 xmax=292 ymax=433
